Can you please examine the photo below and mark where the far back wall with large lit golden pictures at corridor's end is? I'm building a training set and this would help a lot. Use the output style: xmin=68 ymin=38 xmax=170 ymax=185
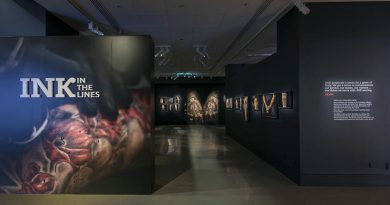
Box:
xmin=155 ymin=80 xmax=225 ymax=125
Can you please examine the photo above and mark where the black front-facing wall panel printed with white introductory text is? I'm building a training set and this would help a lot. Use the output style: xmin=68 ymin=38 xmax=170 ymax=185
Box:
xmin=300 ymin=2 xmax=390 ymax=185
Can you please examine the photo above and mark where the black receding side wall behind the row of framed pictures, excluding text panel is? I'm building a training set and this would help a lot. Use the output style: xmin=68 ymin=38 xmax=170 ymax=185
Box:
xmin=226 ymin=8 xmax=300 ymax=182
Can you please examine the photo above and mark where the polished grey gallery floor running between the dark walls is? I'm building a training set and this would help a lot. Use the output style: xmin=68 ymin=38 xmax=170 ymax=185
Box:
xmin=0 ymin=126 xmax=390 ymax=205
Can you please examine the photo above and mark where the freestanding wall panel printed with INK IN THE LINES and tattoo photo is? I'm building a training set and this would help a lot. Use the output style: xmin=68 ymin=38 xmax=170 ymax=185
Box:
xmin=0 ymin=36 xmax=154 ymax=194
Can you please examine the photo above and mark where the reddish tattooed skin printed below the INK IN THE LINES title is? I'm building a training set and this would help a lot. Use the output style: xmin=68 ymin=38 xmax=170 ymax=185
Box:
xmin=0 ymin=94 xmax=150 ymax=194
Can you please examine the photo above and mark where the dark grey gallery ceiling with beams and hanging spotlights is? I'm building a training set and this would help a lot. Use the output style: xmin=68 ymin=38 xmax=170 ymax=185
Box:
xmin=35 ymin=0 xmax=293 ymax=76
